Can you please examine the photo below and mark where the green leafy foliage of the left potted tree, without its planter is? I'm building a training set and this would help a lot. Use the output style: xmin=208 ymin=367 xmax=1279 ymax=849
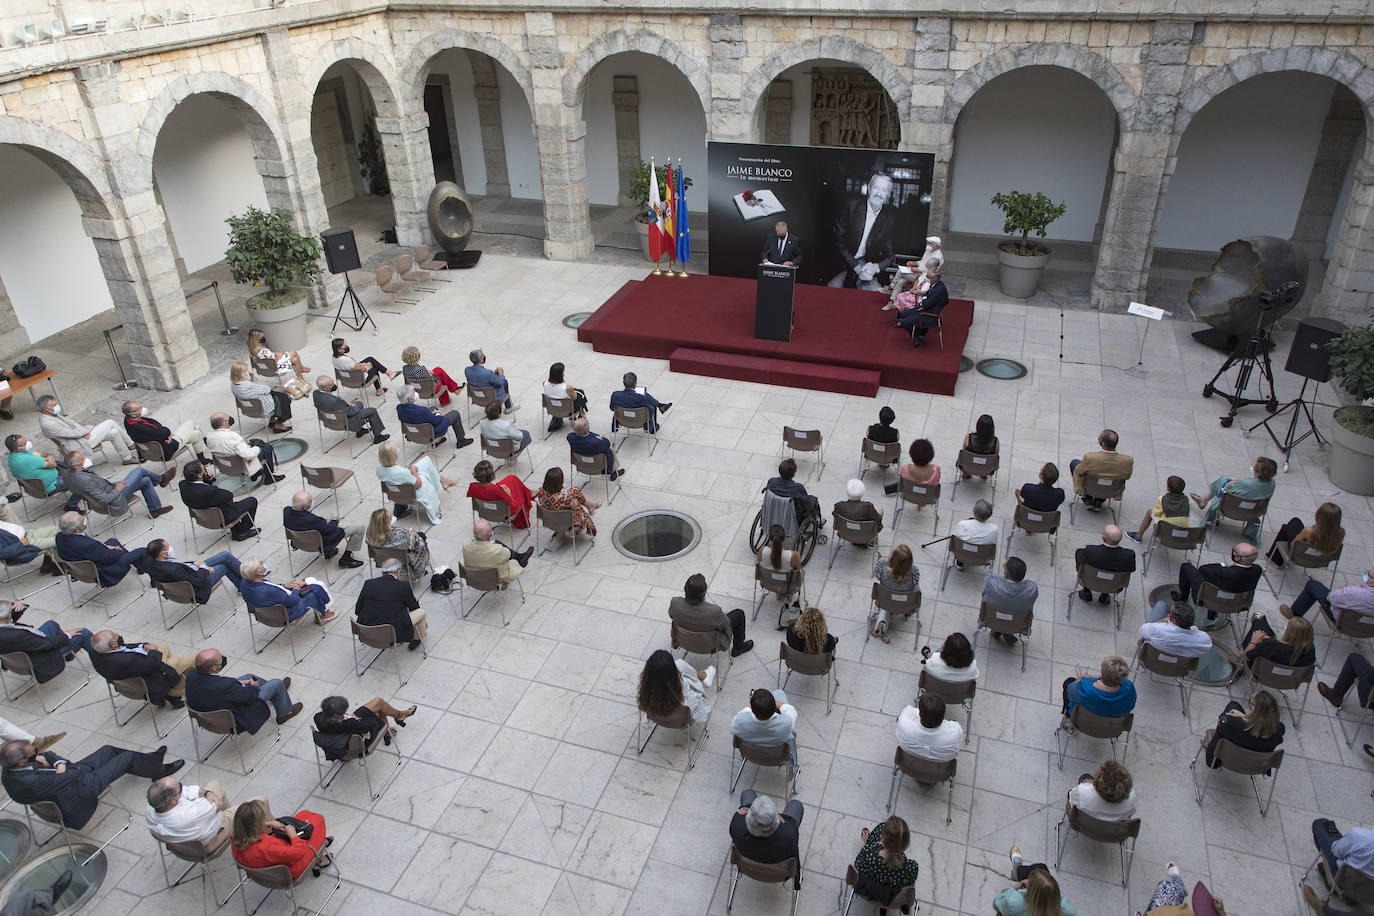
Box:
xmin=224 ymin=206 xmax=322 ymax=309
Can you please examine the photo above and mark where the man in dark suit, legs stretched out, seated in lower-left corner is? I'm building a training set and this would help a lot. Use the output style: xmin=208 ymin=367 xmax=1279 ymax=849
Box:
xmin=0 ymin=742 xmax=185 ymax=829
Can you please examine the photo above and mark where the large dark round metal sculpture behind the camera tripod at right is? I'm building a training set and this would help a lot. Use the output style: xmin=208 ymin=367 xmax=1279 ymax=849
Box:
xmin=1189 ymin=235 xmax=1308 ymax=352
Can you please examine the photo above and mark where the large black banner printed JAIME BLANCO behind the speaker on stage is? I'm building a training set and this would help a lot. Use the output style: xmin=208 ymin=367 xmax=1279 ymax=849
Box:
xmin=706 ymin=143 xmax=936 ymax=288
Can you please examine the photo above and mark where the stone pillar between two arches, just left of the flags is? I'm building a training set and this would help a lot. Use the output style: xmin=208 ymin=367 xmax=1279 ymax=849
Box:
xmin=525 ymin=12 xmax=596 ymax=261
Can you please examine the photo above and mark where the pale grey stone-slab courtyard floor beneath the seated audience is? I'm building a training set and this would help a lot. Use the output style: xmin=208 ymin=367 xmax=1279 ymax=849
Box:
xmin=0 ymin=238 xmax=1374 ymax=916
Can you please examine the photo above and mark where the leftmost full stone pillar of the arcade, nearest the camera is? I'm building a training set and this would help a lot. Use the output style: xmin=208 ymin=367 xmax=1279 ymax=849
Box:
xmin=77 ymin=63 xmax=210 ymax=390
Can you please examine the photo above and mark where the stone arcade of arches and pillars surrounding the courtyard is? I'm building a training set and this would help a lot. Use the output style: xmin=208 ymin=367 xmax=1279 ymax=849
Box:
xmin=0 ymin=8 xmax=1374 ymax=389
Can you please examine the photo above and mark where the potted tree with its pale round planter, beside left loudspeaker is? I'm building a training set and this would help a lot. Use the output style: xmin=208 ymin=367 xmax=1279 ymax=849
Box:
xmin=224 ymin=206 xmax=322 ymax=350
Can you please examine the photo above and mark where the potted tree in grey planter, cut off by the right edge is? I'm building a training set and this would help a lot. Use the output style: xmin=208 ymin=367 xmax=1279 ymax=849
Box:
xmin=1326 ymin=323 xmax=1374 ymax=496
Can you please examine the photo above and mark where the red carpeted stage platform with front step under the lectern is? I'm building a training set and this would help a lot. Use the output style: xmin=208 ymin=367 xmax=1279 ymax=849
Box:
xmin=577 ymin=273 xmax=973 ymax=397
